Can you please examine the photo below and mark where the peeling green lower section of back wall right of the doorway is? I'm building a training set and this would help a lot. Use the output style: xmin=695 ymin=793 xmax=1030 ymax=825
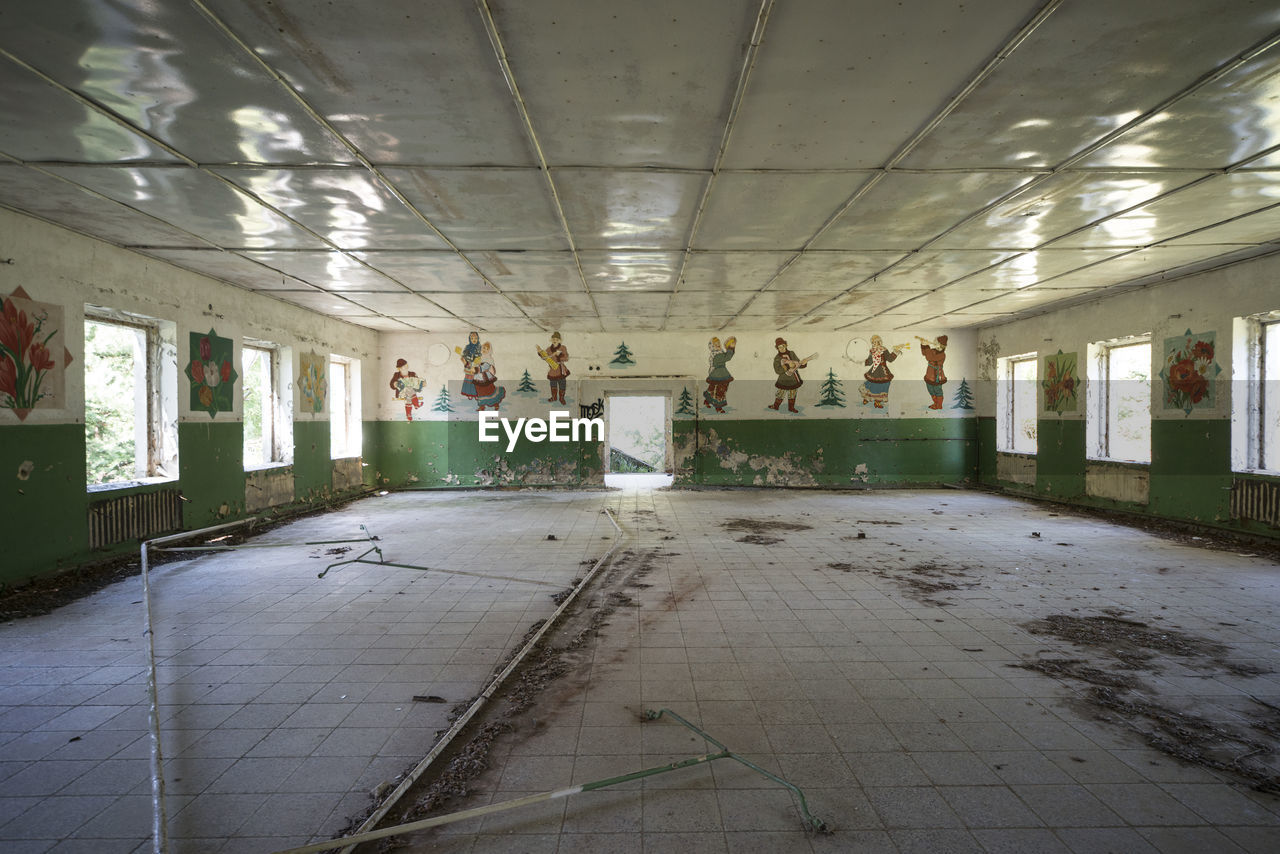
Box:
xmin=672 ymin=419 xmax=978 ymax=487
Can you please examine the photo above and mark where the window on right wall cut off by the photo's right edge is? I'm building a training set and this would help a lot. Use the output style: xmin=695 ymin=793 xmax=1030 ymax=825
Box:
xmin=1231 ymin=311 xmax=1280 ymax=471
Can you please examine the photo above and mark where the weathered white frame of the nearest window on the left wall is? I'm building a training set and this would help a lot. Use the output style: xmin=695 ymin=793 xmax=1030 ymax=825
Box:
xmin=83 ymin=311 xmax=179 ymax=493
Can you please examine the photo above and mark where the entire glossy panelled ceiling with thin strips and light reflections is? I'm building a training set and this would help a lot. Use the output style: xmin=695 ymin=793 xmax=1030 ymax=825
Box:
xmin=0 ymin=0 xmax=1280 ymax=332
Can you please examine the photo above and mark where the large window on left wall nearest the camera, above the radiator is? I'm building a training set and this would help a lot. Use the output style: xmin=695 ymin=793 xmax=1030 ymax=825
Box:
xmin=84 ymin=312 xmax=178 ymax=488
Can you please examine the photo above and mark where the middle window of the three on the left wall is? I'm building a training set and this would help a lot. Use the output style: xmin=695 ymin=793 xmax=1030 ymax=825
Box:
xmin=241 ymin=341 xmax=293 ymax=469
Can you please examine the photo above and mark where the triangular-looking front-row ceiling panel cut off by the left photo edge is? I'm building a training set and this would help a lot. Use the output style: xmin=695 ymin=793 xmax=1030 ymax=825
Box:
xmin=0 ymin=61 xmax=179 ymax=163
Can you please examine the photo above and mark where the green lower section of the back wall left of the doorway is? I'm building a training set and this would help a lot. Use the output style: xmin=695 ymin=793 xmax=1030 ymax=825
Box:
xmin=371 ymin=421 xmax=604 ymax=487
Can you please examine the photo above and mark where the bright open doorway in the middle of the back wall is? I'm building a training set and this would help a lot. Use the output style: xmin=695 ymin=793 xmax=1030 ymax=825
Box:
xmin=604 ymin=394 xmax=672 ymax=489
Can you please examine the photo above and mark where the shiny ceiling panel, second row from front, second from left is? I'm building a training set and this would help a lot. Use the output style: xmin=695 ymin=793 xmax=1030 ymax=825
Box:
xmin=49 ymin=166 xmax=324 ymax=248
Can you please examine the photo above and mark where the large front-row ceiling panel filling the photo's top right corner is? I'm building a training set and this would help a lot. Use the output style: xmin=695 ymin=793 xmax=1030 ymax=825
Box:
xmin=902 ymin=0 xmax=1277 ymax=168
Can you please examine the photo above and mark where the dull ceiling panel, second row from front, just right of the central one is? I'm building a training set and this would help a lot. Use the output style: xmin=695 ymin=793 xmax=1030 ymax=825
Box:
xmin=694 ymin=172 xmax=869 ymax=250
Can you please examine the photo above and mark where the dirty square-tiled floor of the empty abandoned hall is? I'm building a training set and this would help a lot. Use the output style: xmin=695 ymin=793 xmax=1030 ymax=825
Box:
xmin=0 ymin=488 xmax=1280 ymax=854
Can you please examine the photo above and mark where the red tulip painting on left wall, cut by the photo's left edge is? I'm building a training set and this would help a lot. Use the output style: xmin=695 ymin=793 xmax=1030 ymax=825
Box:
xmin=0 ymin=288 xmax=72 ymax=421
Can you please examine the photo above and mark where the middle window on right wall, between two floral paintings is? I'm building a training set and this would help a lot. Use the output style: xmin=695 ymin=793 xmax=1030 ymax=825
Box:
xmin=1085 ymin=338 xmax=1151 ymax=462
